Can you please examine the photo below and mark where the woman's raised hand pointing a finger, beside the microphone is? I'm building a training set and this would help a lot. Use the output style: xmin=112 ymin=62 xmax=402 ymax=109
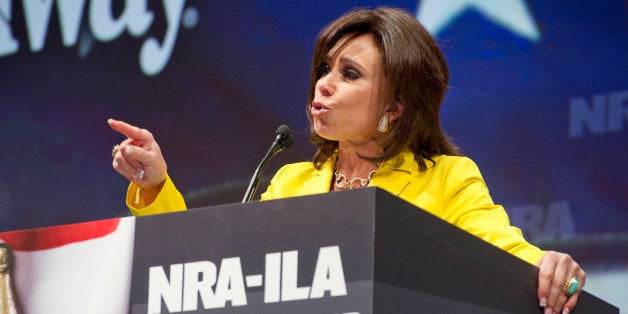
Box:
xmin=107 ymin=119 xmax=168 ymax=203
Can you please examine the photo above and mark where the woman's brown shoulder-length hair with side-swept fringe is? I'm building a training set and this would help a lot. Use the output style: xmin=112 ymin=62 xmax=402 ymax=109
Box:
xmin=306 ymin=7 xmax=460 ymax=171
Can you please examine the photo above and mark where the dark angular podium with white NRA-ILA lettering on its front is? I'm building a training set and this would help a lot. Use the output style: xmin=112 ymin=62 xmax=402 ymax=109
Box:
xmin=0 ymin=188 xmax=619 ymax=314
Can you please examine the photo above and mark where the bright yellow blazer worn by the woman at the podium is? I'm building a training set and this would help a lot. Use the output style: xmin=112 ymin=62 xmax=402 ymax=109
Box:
xmin=127 ymin=150 xmax=544 ymax=264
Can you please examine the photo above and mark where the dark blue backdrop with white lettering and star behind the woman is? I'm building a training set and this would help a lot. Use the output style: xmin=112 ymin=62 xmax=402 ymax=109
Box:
xmin=0 ymin=0 xmax=628 ymax=272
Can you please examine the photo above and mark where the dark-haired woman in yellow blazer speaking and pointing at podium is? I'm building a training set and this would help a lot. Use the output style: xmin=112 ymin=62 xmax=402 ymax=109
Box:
xmin=109 ymin=8 xmax=586 ymax=313
